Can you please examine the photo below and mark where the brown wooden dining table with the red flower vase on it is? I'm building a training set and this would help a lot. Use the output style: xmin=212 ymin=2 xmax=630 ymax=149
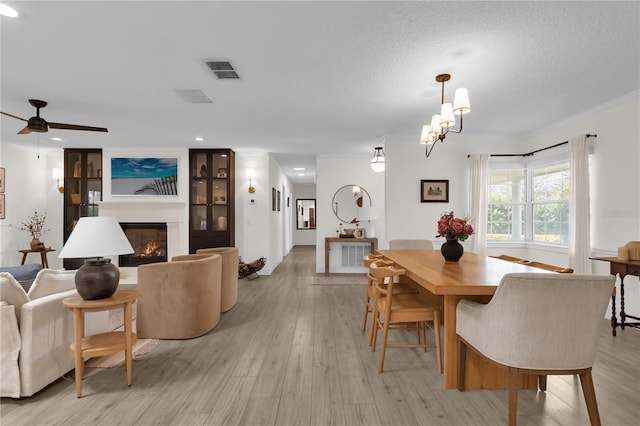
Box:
xmin=378 ymin=250 xmax=549 ymax=389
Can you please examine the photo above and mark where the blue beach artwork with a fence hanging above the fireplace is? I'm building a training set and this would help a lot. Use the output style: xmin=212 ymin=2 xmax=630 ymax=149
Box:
xmin=111 ymin=157 xmax=178 ymax=196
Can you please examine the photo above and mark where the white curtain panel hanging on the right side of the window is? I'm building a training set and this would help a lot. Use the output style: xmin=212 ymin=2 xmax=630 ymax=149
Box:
xmin=569 ymin=135 xmax=591 ymax=274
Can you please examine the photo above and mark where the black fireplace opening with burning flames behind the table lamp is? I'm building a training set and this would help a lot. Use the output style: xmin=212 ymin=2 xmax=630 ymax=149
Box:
xmin=118 ymin=222 xmax=167 ymax=267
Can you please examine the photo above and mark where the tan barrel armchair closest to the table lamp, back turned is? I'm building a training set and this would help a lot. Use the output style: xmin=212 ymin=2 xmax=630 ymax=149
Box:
xmin=136 ymin=254 xmax=222 ymax=339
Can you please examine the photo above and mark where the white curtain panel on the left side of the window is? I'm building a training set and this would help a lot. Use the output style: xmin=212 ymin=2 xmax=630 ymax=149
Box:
xmin=469 ymin=154 xmax=489 ymax=256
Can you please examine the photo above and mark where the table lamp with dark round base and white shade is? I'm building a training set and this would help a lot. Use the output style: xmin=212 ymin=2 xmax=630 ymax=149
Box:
xmin=58 ymin=216 xmax=133 ymax=300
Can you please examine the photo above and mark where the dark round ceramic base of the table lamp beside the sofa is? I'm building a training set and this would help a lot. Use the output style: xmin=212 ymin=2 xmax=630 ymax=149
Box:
xmin=76 ymin=258 xmax=120 ymax=300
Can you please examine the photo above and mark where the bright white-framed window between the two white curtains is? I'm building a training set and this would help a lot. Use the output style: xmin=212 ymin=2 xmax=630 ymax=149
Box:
xmin=487 ymin=161 xmax=570 ymax=245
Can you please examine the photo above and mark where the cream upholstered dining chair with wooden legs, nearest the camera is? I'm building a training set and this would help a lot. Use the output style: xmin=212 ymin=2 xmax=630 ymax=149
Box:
xmin=456 ymin=273 xmax=615 ymax=426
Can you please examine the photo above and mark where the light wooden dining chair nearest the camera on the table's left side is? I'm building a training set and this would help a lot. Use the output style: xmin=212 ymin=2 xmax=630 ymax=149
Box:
xmin=369 ymin=262 xmax=442 ymax=373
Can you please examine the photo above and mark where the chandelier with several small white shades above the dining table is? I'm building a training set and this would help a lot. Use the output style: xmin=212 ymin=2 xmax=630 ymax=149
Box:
xmin=420 ymin=74 xmax=471 ymax=157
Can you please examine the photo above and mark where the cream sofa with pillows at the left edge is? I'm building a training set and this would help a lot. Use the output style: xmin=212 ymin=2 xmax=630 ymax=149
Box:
xmin=0 ymin=269 xmax=109 ymax=398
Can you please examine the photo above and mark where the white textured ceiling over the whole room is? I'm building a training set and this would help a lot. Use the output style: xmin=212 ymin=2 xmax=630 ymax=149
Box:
xmin=0 ymin=1 xmax=640 ymax=183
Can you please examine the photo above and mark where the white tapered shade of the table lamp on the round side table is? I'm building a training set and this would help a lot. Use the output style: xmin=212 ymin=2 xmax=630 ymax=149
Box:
xmin=58 ymin=216 xmax=133 ymax=259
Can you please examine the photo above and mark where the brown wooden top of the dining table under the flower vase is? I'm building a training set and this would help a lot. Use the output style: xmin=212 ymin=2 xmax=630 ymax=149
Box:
xmin=378 ymin=250 xmax=549 ymax=296
